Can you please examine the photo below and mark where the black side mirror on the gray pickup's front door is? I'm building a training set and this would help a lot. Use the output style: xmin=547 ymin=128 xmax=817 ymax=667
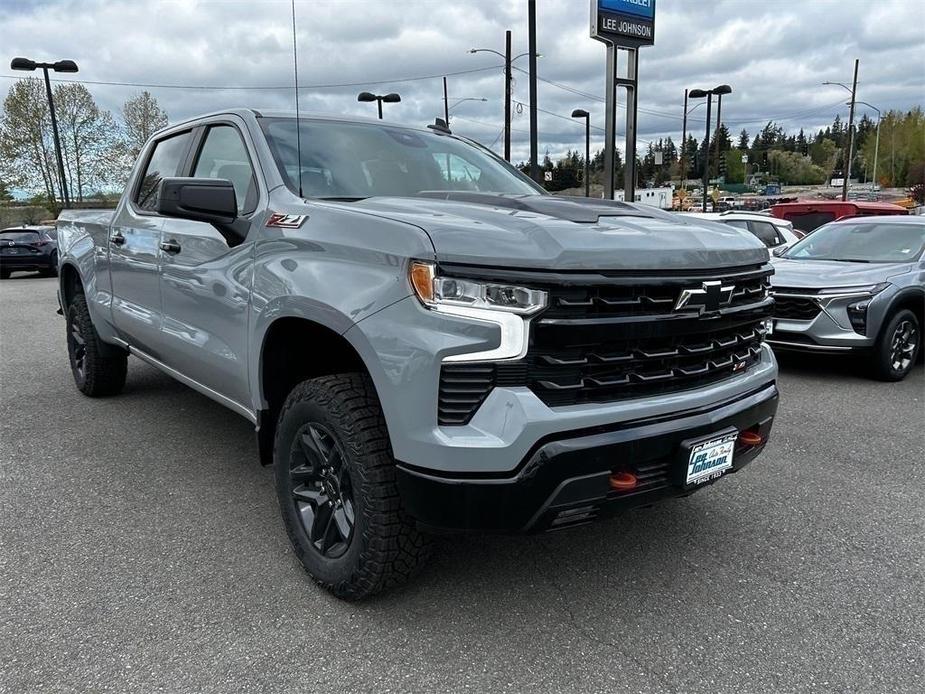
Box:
xmin=157 ymin=177 xmax=249 ymax=247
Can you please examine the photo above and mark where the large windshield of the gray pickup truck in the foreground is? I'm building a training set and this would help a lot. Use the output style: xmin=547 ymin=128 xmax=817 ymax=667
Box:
xmin=260 ymin=118 xmax=543 ymax=198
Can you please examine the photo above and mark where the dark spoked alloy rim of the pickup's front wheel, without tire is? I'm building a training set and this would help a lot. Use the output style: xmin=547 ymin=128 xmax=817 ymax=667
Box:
xmin=289 ymin=422 xmax=356 ymax=559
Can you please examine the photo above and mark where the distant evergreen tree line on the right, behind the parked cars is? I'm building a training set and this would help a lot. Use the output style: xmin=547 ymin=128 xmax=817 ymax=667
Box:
xmin=520 ymin=107 xmax=925 ymax=191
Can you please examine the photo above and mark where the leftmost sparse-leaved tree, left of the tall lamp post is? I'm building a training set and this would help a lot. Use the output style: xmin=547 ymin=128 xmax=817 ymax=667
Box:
xmin=0 ymin=77 xmax=61 ymax=206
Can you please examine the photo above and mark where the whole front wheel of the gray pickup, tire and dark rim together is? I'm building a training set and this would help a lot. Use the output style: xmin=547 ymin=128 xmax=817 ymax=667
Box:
xmin=273 ymin=374 xmax=430 ymax=600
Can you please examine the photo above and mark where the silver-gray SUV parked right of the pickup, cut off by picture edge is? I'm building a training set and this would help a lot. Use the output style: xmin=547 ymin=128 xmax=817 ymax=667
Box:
xmin=768 ymin=216 xmax=925 ymax=381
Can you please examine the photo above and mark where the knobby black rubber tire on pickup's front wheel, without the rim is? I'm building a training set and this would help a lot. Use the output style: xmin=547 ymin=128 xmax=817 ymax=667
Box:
xmin=273 ymin=373 xmax=432 ymax=600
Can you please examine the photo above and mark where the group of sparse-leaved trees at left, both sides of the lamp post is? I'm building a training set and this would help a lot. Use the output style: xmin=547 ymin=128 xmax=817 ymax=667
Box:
xmin=0 ymin=78 xmax=167 ymax=211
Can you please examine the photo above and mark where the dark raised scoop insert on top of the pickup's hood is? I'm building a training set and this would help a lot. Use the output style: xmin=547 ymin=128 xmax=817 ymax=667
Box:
xmin=415 ymin=191 xmax=659 ymax=224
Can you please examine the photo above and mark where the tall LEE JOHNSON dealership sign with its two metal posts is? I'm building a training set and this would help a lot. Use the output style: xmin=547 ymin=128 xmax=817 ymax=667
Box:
xmin=591 ymin=0 xmax=655 ymax=202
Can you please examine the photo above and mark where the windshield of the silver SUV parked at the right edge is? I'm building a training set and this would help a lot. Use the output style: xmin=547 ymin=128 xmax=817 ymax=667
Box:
xmin=784 ymin=222 xmax=925 ymax=263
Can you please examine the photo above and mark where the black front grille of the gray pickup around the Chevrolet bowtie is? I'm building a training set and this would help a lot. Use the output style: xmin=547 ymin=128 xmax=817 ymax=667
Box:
xmin=438 ymin=266 xmax=773 ymax=424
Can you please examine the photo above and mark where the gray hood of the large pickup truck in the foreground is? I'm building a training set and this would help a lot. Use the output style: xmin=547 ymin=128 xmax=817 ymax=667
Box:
xmin=340 ymin=193 xmax=768 ymax=270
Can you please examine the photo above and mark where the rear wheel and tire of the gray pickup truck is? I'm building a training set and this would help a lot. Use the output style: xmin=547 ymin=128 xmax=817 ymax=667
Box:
xmin=67 ymin=293 xmax=128 ymax=398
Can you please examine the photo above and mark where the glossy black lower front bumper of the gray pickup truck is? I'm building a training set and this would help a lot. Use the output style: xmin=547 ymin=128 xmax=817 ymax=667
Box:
xmin=398 ymin=382 xmax=778 ymax=531
